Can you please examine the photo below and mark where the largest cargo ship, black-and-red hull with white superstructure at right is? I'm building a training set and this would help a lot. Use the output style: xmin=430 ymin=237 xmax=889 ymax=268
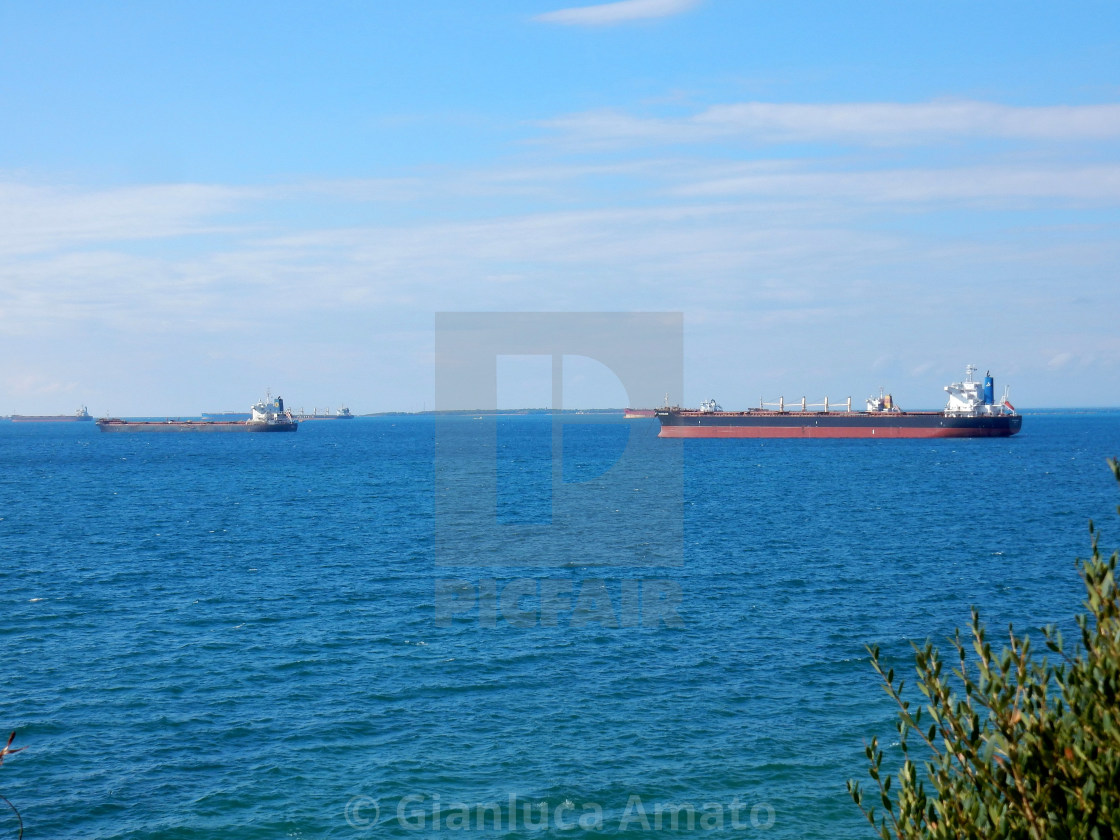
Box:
xmin=657 ymin=365 xmax=1023 ymax=438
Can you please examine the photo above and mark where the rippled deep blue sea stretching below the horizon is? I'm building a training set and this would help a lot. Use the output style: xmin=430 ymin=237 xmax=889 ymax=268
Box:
xmin=0 ymin=412 xmax=1120 ymax=839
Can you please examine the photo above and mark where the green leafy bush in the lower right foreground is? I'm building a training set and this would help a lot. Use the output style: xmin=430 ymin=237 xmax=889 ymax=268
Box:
xmin=848 ymin=460 xmax=1120 ymax=840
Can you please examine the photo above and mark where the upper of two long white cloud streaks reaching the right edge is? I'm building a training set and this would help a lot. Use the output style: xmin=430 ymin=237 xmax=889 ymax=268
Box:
xmin=544 ymin=101 xmax=1120 ymax=147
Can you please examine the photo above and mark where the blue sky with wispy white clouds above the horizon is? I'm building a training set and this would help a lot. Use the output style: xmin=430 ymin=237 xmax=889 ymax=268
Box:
xmin=0 ymin=0 xmax=1120 ymax=414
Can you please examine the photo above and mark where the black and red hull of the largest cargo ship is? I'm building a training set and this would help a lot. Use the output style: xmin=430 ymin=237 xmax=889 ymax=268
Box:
xmin=657 ymin=411 xmax=1023 ymax=438
